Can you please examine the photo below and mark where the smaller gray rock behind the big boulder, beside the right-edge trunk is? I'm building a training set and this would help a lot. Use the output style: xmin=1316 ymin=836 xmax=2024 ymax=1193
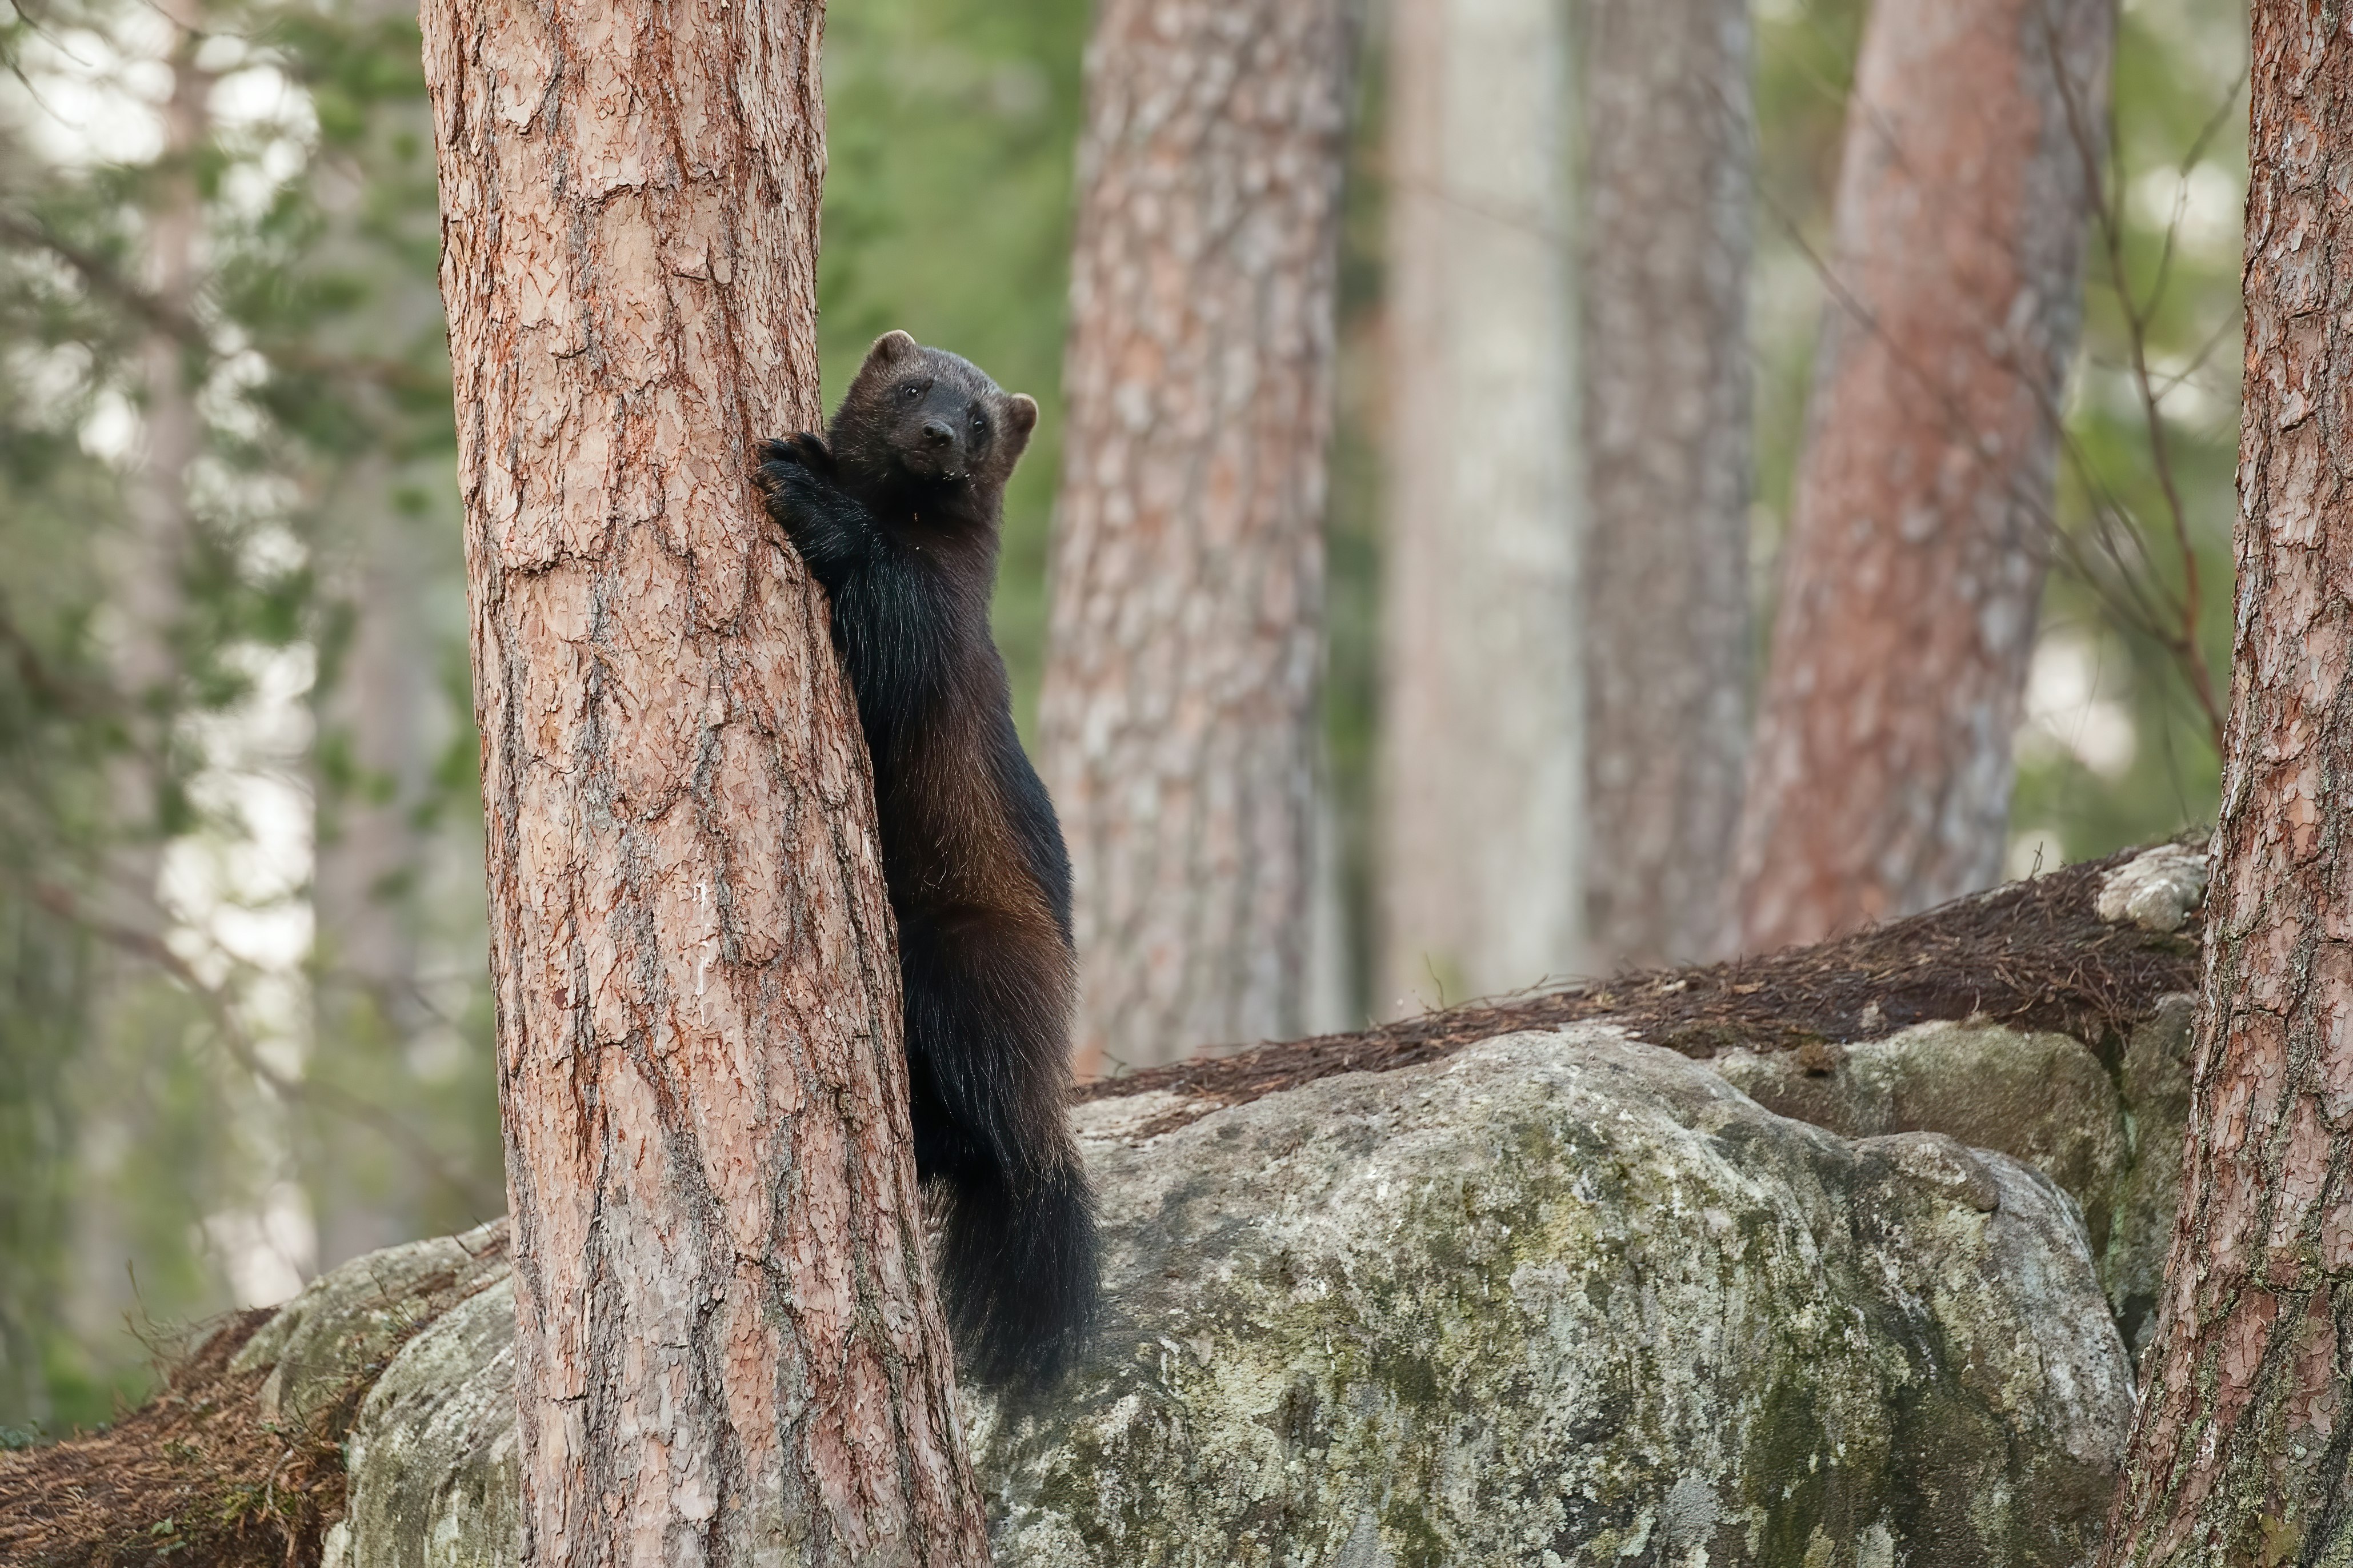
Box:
xmin=1708 ymin=1001 xmax=2198 ymax=1354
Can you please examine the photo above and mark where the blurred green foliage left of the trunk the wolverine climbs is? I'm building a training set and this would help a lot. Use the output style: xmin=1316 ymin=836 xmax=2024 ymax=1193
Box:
xmin=0 ymin=0 xmax=499 ymax=1429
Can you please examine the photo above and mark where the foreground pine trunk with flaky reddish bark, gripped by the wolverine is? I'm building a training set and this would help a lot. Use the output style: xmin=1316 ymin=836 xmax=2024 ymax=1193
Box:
xmin=423 ymin=0 xmax=986 ymax=1563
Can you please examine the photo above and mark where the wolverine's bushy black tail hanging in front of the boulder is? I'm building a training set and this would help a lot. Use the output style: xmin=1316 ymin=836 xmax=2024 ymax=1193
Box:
xmin=934 ymin=1149 xmax=1097 ymax=1391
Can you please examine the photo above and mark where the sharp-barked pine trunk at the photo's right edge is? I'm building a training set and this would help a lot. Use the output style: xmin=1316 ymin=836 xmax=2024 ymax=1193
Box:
xmin=2101 ymin=0 xmax=2353 ymax=1563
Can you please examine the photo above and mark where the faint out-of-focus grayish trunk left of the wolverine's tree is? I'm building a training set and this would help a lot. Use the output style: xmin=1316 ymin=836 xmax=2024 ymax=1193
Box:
xmin=303 ymin=0 xmax=454 ymax=1267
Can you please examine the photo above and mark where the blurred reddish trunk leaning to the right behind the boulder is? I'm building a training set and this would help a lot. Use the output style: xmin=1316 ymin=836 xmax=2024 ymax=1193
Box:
xmin=1734 ymin=0 xmax=2115 ymax=952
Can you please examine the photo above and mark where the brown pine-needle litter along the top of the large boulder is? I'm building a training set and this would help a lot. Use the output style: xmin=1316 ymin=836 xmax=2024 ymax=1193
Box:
xmin=1078 ymin=849 xmax=2200 ymax=1105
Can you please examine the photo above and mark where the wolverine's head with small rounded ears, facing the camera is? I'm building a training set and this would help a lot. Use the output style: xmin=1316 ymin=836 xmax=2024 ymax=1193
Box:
xmin=833 ymin=331 xmax=1038 ymax=487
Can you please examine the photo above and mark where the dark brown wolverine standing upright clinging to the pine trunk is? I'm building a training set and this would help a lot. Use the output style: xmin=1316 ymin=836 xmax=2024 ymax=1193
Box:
xmin=758 ymin=331 xmax=1097 ymax=1387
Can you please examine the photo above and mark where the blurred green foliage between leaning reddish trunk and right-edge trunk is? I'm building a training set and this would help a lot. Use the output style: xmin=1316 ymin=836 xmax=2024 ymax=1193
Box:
xmin=2012 ymin=0 xmax=2247 ymax=863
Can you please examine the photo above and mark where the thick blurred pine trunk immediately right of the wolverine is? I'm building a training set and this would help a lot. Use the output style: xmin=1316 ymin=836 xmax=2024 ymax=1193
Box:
xmin=1040 ymin=0 xmax=1355 ymax=1077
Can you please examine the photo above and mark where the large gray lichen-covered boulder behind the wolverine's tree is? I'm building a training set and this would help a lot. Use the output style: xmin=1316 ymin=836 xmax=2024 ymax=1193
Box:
xmin=273 ymin=1025 xmax=2132 ymax=1568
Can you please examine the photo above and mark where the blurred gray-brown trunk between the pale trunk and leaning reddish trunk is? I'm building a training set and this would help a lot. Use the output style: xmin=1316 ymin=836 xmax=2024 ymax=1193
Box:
xmin=1579 ymin=0 xmax=1755 ymax=971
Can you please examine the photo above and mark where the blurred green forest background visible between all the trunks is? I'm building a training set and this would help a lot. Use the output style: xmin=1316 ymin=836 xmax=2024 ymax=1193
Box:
xmin=0 ymin=0 xmax=2247 ymax=1437
